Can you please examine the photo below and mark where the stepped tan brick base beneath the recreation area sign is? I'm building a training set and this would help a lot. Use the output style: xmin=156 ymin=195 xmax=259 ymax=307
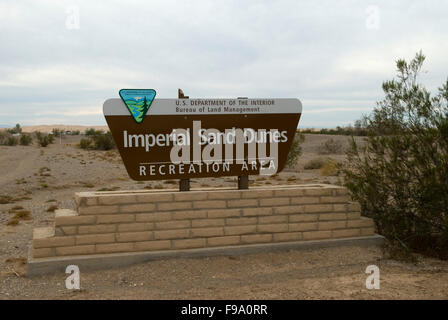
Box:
xmin=28 ymin=184 xmax=383 ymax=275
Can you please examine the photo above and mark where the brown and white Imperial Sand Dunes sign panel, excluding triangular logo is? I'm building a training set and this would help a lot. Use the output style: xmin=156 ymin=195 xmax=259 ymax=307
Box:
xmin=103 ymin=94 xmax=302 ymax=181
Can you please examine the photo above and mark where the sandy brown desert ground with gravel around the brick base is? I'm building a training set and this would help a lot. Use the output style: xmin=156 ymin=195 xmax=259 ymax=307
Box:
xmin=0 ymin=128 xmax=448 ymax=299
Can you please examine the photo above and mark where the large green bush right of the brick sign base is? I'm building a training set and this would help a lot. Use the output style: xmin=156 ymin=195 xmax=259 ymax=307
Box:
xmin=343 ymin=52 xmax=448 ymax=259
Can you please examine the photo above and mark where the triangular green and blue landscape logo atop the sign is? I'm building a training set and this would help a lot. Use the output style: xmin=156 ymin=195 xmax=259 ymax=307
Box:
xmin=119 ymin=89 xmax=156 ymax=123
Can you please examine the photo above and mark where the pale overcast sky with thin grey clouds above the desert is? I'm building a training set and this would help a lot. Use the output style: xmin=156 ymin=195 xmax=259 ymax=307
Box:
xmin=0 ymin=0 xmax=448 ymax=127
